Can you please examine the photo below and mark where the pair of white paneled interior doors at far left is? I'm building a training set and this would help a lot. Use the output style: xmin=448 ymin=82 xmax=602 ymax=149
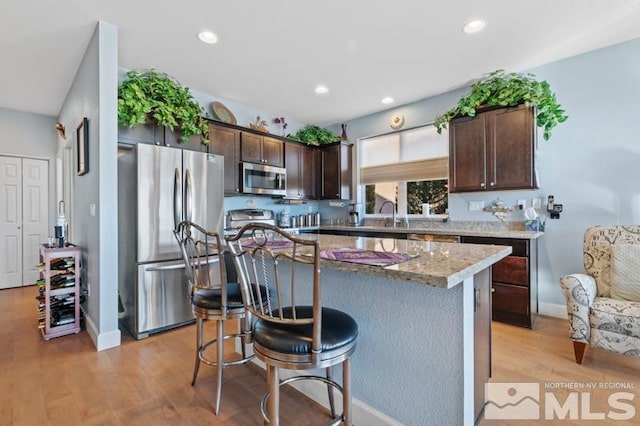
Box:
xmin=0 ymin=156 xmax=49 ymax=288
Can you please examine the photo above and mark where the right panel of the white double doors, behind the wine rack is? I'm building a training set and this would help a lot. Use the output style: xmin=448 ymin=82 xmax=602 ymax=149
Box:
xmin=22 ymin=158 xmax=50 ymax=285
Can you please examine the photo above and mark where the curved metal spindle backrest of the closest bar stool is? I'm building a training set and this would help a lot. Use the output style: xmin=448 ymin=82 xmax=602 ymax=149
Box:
xmin=226 ymin=223 xmax=322 ymax=353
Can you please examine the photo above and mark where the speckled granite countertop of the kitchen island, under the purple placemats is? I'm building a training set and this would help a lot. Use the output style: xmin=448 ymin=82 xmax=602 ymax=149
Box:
xmin=300 ymin=234 xmax=511 ymax=288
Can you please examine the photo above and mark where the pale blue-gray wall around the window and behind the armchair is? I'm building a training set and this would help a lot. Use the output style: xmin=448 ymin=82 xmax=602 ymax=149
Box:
xmin=334 ymin=35 xmax=640 ymax=316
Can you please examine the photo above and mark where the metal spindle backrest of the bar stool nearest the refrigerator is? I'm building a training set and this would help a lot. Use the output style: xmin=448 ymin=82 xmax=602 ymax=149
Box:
xmin=173 ymin=220 xmax=227 ymax=311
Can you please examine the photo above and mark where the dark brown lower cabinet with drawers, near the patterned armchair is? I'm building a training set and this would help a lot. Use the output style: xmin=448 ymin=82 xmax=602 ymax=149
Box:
xmin=462 ymin=236 xmax=538 ymax=328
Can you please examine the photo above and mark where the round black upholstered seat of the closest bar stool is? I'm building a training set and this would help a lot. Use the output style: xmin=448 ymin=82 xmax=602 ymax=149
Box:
xmin=253 ymin=306 xmax=358 ymax=354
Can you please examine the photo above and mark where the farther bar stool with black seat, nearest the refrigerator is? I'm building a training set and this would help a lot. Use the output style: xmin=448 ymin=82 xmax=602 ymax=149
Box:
xmin=173 ymin=221 xmax=254 ymax=415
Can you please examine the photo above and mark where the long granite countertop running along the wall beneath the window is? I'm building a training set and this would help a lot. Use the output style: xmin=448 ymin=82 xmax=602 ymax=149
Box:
xmin=320 ymin=225 xmax=544 ymax=240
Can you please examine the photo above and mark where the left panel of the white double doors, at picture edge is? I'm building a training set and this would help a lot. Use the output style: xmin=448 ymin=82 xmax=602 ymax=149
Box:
xmin=0 ymin=156 xmax=22 ymax=288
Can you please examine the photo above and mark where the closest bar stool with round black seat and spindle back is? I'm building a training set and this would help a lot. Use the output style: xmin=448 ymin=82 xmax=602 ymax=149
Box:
xmin=226 ymin=223 xmax=358 ymax=426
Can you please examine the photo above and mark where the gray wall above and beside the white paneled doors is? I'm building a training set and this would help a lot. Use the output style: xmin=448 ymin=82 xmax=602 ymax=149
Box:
xmin=0 ymin=108 xmax=58 ymax=233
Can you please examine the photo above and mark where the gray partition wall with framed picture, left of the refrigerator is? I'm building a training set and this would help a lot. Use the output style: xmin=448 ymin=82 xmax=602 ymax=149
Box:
xmin=59 ymin=23 xmax=120 ymax=350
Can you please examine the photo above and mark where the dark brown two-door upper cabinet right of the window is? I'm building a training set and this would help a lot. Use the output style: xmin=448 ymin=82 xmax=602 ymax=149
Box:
xmin=449 ymin=105 xmax=537 ymax=192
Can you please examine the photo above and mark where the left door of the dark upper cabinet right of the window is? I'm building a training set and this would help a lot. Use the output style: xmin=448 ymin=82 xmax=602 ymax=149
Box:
xmin=449 ymin=114 xmax=486 ymax=192
